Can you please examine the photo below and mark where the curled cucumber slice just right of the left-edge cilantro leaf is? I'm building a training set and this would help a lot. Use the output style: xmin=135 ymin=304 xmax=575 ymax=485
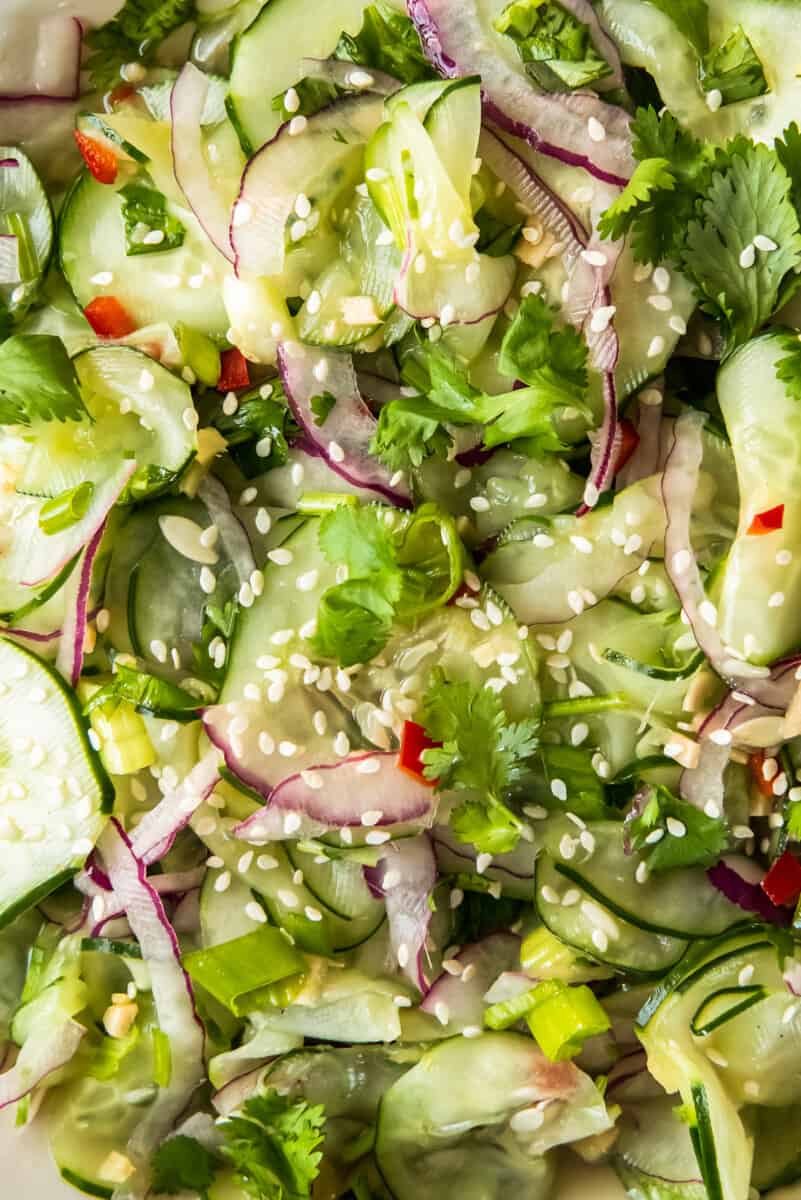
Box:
xmin=17 ymin=346 xmax=197 ymax=503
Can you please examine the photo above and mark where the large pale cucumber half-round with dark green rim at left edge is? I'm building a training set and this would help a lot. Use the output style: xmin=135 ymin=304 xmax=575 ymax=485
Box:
xmin=0 ymin=637 xmax=114 ymax=928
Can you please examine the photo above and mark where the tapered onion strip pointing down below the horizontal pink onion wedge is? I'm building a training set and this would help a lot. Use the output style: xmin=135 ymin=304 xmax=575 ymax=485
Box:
xmin=371 ymin=835 xmax=436 ymax=995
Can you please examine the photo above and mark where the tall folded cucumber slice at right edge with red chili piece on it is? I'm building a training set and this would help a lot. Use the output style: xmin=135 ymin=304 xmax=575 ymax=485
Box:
xmin=713 ymin=331 xmax=801 ymax=664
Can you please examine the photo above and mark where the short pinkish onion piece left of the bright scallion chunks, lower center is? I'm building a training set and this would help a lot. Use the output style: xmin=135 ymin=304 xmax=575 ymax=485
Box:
xmin=420 ymin=934 xmax=520 ymax=1037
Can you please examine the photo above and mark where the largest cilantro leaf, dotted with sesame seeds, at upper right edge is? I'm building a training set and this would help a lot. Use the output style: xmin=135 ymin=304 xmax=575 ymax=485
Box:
xmin=681 ymin=143 xmax=801 ymax=347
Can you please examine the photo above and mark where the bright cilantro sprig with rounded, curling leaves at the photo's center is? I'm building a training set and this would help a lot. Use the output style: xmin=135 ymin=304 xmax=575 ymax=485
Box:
xmin=314 ymin=504 xmax=464 ymax=666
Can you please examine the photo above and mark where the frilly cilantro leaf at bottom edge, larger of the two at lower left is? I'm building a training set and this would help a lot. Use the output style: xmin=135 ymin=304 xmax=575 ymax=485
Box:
xmin=221 ymin=1091 xmax=325 ymax=1200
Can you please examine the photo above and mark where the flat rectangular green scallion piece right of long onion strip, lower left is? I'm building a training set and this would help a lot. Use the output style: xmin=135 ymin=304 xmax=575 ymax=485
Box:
xmin=183 ymin=925 xmax=306 ymax=1016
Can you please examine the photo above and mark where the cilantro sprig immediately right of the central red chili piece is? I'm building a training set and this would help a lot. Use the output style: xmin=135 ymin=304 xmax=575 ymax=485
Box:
xmin=420 ymin=671 xmax=538 ymax=854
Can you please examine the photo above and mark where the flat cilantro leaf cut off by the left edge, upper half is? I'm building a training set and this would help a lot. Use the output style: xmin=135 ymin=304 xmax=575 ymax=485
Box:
xmin=0 ymin=334 xmax=89 ymax=425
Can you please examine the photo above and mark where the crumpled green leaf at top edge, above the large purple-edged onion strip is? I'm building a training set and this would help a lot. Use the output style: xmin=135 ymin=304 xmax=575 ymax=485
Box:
xmin=495 ymin=0 xmax=612 ymax=91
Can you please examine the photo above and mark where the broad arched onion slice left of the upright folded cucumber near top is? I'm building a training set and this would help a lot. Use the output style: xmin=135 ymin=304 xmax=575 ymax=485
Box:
xmin=230 ymin=95 xmax=384 ymax=276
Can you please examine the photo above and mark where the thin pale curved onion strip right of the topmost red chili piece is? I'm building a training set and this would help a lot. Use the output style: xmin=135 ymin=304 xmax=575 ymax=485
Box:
xmin=169 ymin=62 xmax=234 ymax=263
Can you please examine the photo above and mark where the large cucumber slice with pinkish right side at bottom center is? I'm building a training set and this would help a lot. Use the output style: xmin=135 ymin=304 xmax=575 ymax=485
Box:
xmin=375 ymin=1033 xmax=610 ymax=1200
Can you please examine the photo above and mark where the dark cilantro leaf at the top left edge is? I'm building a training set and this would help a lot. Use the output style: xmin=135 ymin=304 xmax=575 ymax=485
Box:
xmin=84 ymin=0 xmax=194 ymax=91
